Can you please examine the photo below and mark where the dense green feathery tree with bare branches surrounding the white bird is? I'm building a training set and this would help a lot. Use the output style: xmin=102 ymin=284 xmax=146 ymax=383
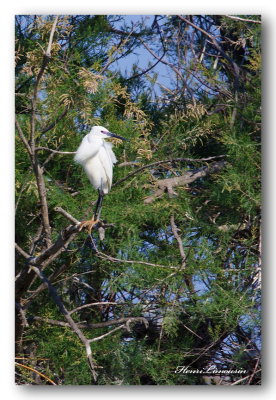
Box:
xmin=15 ymin=15 xmax=261 ymax=385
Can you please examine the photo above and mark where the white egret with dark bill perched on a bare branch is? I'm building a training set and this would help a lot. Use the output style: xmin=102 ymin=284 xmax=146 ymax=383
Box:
xmin=74 ymin=126 xmax=125 ymax=233
